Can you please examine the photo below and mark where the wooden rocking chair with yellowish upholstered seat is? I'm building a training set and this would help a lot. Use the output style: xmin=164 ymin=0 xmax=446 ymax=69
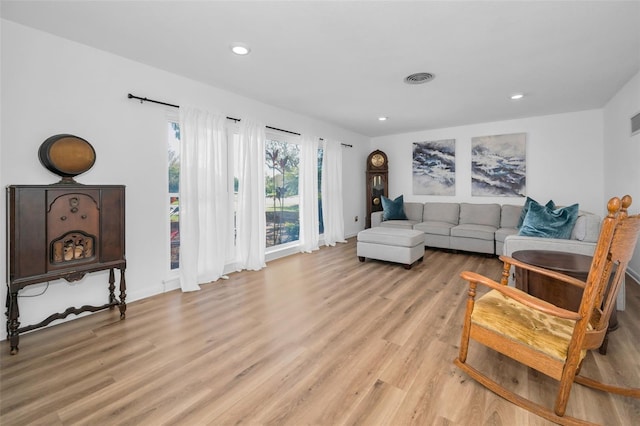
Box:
xmin=454 ymin=195 xmax=640 ymax=424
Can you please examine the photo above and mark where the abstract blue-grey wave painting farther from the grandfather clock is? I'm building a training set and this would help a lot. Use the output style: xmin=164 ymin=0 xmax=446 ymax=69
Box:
xmin=471 ymin=133 xmax=527 ymax=197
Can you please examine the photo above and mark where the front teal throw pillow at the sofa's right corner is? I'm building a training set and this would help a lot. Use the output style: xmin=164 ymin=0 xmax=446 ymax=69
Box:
xmin=518 ymin=203 xmax=578 ymax=240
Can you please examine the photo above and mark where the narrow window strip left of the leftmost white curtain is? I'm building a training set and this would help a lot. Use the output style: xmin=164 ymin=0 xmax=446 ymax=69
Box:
xmin=167 ymin=121 xmax=180 ymax=269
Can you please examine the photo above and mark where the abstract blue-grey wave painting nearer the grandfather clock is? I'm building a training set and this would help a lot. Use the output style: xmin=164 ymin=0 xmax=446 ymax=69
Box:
xmin=413 ymin=139 xmax=456 ymax=195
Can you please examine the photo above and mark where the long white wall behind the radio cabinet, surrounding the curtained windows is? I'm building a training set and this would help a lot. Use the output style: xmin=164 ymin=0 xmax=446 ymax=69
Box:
xmin=0 ymin=20 xmax=369 ymax=339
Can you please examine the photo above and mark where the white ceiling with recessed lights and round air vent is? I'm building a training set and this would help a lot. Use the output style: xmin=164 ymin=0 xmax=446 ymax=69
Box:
xmin=1 ymin=0 xmax=640 ymax=136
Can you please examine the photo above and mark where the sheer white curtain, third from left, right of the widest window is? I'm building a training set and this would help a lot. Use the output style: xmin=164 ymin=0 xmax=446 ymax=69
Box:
xmin=298 ymin=135 xmax=320 ymax=253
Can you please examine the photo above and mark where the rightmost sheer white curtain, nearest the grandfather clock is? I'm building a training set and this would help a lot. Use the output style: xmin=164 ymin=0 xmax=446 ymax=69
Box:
xmin=322 ymin=139 xmax=346 ymax=246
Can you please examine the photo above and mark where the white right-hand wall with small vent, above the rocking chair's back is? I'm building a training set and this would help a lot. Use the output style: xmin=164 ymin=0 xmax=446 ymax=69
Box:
xmin=604 ymin=72 xmax=640 ymax=282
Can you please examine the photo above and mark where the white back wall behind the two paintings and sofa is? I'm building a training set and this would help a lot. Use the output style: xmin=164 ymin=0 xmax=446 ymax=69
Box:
xmin=371 ymin=110 xmax=604 ymax=214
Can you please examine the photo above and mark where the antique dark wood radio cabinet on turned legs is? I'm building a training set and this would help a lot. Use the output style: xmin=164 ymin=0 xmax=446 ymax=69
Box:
xmin=6 ymin=183 xmax=126 ymax=354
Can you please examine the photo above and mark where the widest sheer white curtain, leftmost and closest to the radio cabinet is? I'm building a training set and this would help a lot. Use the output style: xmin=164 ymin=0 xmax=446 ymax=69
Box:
xmin=180 ymin=106 xmax=229 ymax=291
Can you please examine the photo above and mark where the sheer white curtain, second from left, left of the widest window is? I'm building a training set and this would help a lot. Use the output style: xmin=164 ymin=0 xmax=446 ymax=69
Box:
xmin=236 ymin=119 xmax=266 ymax=271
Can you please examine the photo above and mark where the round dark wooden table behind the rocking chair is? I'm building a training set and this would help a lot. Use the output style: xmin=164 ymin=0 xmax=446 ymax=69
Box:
xmin=511 ymin=250 xmax=618 ymax=354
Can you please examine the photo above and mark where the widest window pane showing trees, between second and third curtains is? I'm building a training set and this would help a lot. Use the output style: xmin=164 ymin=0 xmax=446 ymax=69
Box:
xmin=265 ymin=136 xmax=300 ymax=248
